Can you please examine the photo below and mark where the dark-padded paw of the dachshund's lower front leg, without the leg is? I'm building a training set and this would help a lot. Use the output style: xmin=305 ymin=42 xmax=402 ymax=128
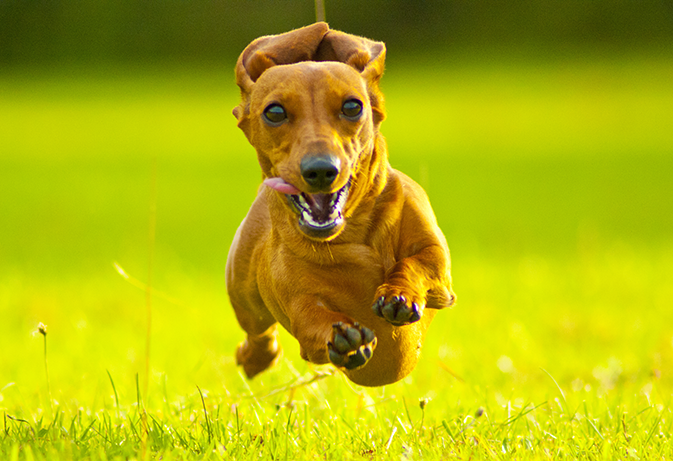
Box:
xmin=327 ymin=322 xmax=376 ymax=370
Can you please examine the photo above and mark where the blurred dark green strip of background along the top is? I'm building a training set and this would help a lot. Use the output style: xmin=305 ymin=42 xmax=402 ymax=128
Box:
xmin=0 ymin=0 xmax=673 ymax=65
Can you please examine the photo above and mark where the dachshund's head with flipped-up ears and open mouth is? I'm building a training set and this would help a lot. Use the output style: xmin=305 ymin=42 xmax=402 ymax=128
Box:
xmin=234 ymin=23 xmax=385 ymax=240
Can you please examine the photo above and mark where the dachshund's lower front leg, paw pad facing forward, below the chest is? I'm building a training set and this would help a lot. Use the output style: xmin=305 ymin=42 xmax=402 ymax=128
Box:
xmin=290 ymin=296 xmax=376 ymax=370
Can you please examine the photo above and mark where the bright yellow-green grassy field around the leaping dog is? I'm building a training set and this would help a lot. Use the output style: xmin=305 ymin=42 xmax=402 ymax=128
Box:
xmin=0 ymin=56 xmax=673 ymax=460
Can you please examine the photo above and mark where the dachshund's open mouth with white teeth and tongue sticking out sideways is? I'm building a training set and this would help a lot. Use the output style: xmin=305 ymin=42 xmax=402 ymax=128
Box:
xmin=264 ymin=178 xmax=350 ymax=239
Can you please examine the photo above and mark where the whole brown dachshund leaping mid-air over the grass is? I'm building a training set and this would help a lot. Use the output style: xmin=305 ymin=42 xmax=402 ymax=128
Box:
xmin=226 ymin=23 xmax=454 ymax=386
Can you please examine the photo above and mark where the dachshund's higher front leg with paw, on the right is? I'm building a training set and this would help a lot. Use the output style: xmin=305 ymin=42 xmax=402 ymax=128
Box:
xmin=372 ymin=244 xmax=455 ymax=326
